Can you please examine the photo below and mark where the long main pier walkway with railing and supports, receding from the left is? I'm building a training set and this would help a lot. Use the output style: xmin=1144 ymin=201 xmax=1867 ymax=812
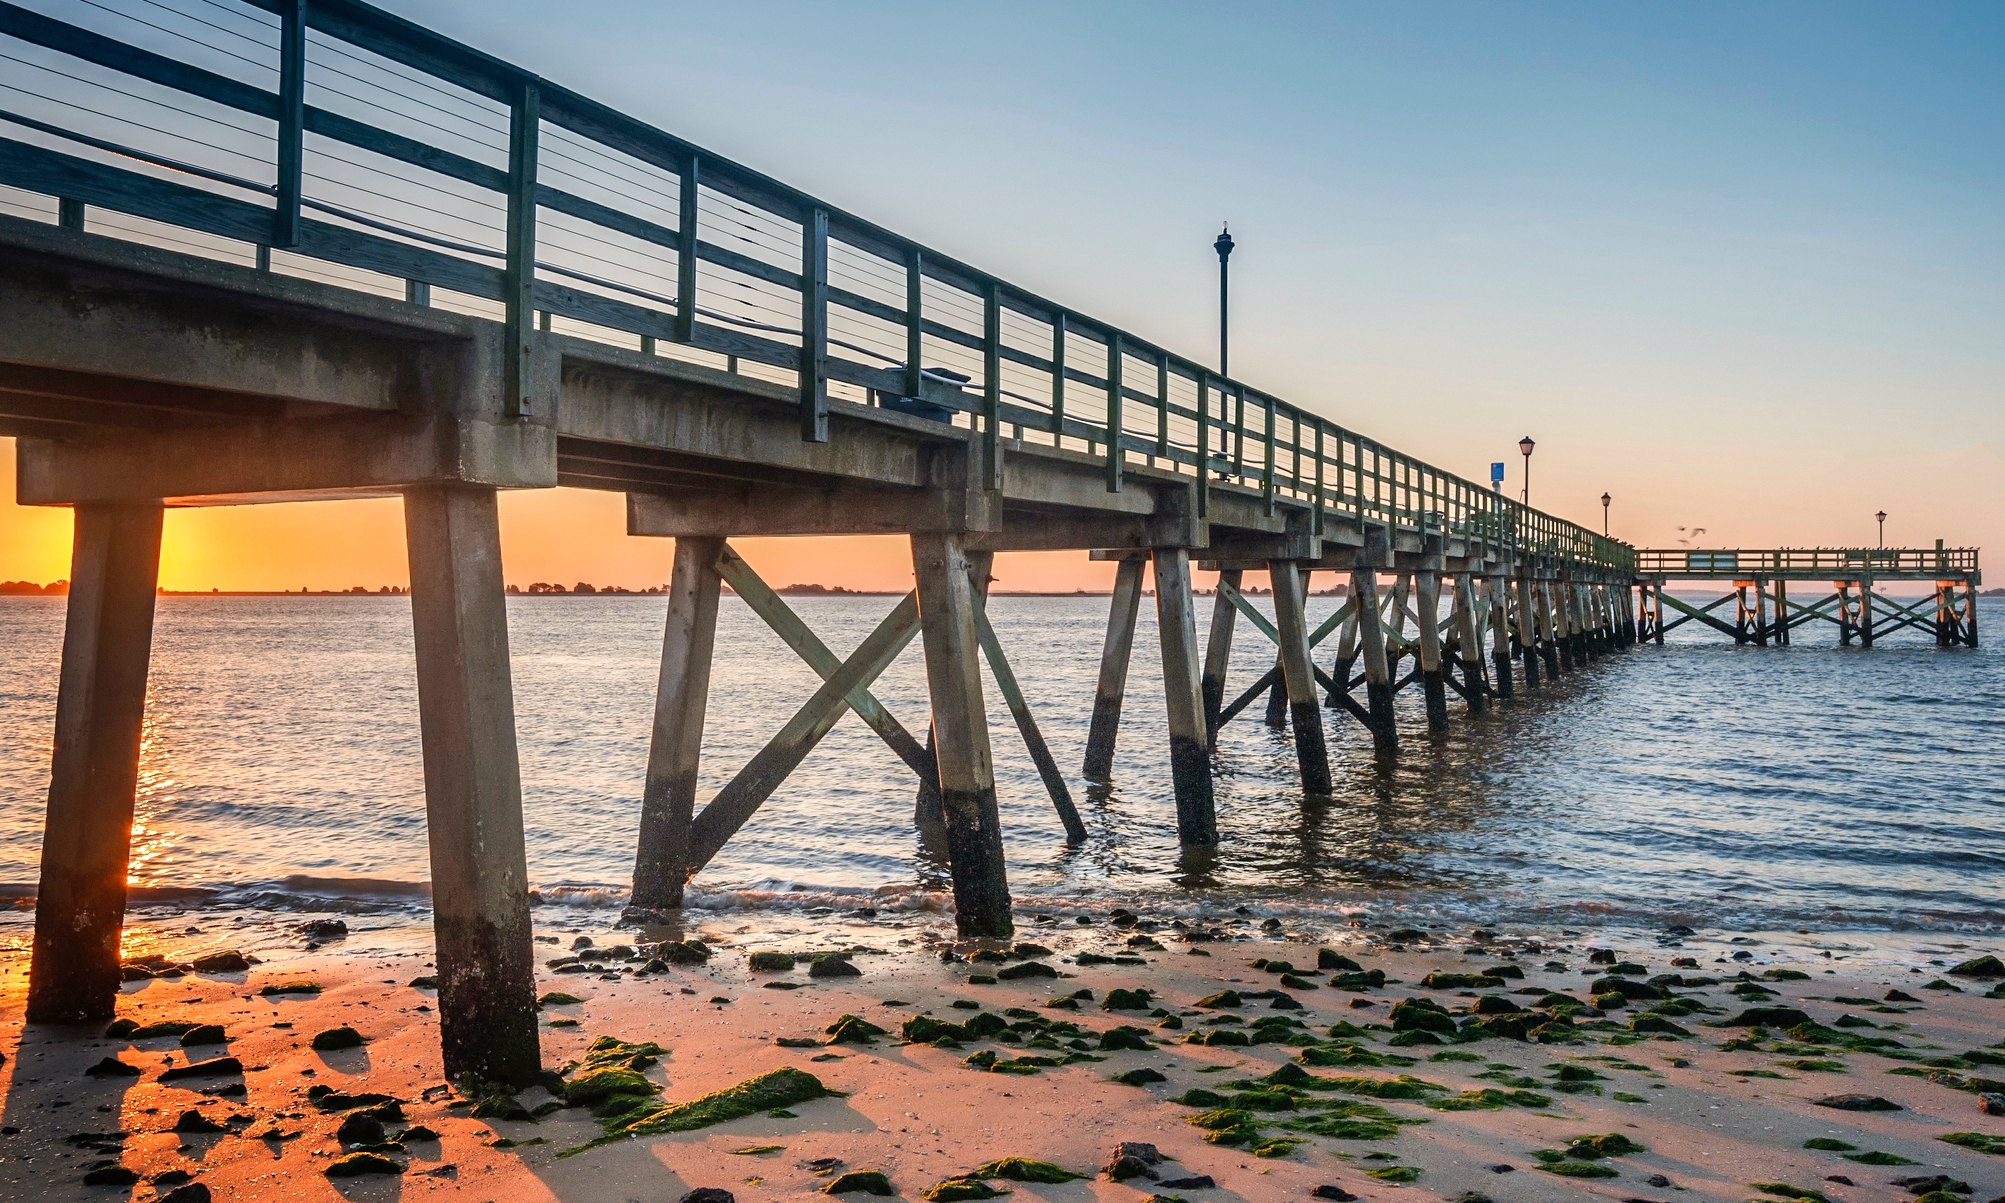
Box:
xmin=0 ymin=0 xmax=1652 ymax=1085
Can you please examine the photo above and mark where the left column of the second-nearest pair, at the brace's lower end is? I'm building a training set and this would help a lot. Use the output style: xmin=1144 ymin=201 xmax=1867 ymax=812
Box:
xmin=634 ymin=537 xmax=724 ymax=910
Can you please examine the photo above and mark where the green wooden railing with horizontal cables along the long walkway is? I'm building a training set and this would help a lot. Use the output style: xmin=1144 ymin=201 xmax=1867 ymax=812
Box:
xmin=0 ymin=0 xmax=1632 ymax=569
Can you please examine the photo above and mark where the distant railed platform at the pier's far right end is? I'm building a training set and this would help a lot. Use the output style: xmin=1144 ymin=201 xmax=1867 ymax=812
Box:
xmin=1636 ymin=539 xmax=1983 ymax=648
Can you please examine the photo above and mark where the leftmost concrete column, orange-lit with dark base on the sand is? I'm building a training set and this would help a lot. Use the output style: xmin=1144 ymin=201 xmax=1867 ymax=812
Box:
xmin=28 ymin=505 xmax=160 ymax=1023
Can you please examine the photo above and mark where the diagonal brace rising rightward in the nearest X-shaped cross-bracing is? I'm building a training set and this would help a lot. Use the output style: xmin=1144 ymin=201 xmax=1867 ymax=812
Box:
xmin=688 ymin=593 xmax=918 ymax=876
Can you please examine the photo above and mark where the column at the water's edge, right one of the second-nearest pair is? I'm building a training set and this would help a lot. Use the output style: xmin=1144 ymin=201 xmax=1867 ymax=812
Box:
xmin=912 ymin=531 xmax=1018 ymax=938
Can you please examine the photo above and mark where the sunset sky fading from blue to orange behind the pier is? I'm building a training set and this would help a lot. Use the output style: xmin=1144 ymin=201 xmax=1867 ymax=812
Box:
xmin=0 ymin=0 xmax=2005 ymax=589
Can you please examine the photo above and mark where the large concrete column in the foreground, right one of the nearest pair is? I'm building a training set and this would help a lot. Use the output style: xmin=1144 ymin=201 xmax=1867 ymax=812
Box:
xmin=403 ymin=485 xmax=541 ymax=1087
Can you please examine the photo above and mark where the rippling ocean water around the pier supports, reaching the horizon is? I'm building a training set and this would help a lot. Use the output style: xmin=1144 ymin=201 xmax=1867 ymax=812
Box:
xmin=0 ymin=595 xmax=2005 ymax=948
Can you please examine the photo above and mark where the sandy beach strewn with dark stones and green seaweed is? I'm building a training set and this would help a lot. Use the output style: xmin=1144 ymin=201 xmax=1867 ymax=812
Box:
xmin=0 ymin=912 xmax=2005 ymax=1203
